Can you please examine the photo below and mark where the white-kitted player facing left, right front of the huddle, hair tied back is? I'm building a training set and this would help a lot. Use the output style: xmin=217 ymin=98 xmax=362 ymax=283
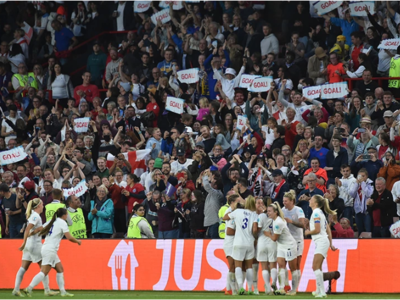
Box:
xmin=264 ymin=202 xmax=297 ymax=296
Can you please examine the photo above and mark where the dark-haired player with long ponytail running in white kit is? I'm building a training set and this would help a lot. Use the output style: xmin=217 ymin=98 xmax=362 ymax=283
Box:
xmin=24 ymin=208 xmax=81 ymax=297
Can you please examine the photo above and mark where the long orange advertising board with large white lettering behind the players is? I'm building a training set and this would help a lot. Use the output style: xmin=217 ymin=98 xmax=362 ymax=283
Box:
xmin=0 ymin=239 xmax=400 ymax=293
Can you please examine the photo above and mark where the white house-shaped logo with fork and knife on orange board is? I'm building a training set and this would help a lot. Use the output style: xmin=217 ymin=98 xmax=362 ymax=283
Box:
xmin=108 ymin=240 xmax=139 ymax=290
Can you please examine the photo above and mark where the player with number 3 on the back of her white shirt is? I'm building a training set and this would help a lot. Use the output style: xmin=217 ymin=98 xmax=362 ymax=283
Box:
xmin=223 ymin=196 xmax=257 ymax=295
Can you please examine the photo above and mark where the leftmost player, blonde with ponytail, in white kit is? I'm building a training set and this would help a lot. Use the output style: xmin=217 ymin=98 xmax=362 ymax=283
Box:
xmin=12 ymin=198 xmax=58 ymax=297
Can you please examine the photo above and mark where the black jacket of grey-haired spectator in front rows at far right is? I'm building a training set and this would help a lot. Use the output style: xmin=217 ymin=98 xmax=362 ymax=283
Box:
xmin=367 ymin=189 xmax=397 ymax=226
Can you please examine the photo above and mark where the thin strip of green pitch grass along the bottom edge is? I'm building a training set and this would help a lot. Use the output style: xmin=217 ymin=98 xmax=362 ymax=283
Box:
xmin=0 ymin=290 xmax=400 ymax=299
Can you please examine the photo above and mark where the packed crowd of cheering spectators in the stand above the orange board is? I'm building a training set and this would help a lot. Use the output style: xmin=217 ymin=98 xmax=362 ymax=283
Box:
xmin=0 ymin=1 xmax=400 ymax=238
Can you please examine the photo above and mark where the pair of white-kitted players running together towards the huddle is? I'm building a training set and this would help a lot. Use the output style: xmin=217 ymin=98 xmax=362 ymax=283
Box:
xmin=12 ymin=198 xmax=81 ymax=297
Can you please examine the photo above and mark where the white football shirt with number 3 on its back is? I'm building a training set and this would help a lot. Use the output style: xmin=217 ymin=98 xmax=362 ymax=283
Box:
xmin=229 ymin=208 xmax=258 ymax=246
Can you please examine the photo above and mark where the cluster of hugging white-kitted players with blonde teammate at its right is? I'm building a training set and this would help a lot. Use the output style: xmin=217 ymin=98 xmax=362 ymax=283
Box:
xmin=223 ymin=190 xmax=336 ymax=298
